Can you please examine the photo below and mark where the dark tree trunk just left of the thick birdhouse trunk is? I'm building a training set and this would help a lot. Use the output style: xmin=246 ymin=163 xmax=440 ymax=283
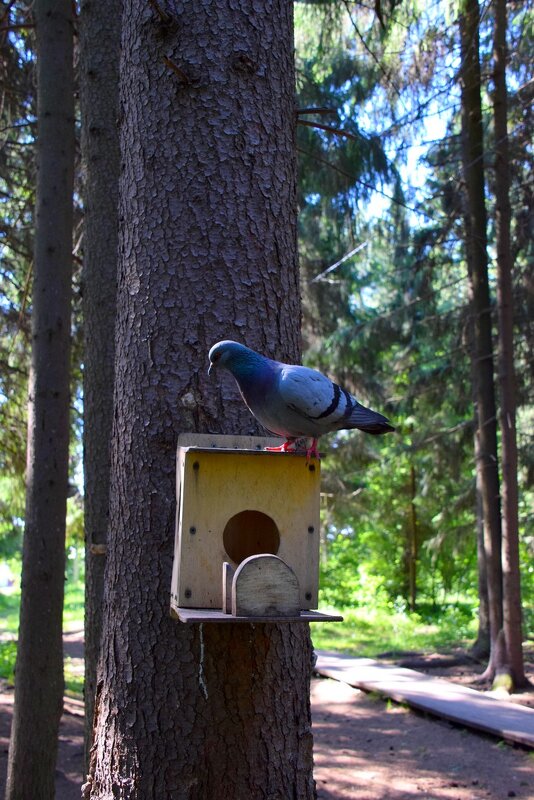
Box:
xmin=80 ymin=0 xmax=122 ymax=766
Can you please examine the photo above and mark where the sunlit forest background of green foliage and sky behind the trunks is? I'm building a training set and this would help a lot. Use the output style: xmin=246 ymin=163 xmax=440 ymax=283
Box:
xmin=0 ymin=0 xmax=534 ymax=720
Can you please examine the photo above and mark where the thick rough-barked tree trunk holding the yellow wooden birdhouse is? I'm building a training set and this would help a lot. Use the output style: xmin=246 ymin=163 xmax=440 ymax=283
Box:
xmin=84 ymin=0 xmax=314 ymax=800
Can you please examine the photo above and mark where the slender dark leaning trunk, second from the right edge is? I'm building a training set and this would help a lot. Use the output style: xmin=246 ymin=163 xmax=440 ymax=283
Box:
xmin=460 ymin=0 xmax=502 ymax=677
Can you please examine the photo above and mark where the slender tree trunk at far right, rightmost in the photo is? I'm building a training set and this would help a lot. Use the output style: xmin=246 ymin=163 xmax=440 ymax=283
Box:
xmin=493 ymin=0 xmax=528 ymax=687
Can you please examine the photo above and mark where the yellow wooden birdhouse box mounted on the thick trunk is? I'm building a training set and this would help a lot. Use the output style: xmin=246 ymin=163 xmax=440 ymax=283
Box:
xmin=171 ymin=434 xmax=342 ymax=622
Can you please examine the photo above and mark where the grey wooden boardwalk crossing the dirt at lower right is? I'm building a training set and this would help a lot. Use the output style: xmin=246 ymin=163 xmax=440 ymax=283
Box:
xmin=315 ymin=650 xmax=534 ymax=748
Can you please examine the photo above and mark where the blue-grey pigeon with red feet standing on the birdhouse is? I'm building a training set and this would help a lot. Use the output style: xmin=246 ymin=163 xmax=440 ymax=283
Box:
xmin=208 ymin=340 xmax=395 ymax=461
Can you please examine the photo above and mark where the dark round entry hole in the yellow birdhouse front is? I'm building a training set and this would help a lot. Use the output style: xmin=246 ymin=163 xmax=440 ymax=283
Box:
xmin=223 ymin=511 xmax=280 ymax=564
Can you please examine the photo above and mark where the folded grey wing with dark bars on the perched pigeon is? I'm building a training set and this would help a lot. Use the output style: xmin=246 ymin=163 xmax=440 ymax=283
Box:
xmin=278 ymin=365 xmax=355 ymax=430
